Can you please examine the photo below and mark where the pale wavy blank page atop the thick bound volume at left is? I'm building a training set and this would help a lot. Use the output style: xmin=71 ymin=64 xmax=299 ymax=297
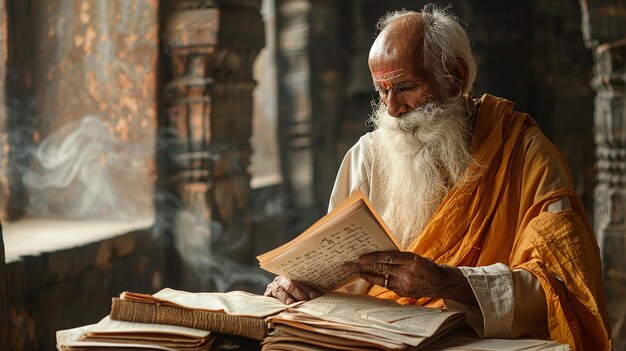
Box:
xmin=154 ymin=288 xmax=300 ymax=318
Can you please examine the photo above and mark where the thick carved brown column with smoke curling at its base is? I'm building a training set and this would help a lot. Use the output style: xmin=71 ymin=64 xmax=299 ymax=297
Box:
xmin=163 ymin=0 xmax=264 ymax=290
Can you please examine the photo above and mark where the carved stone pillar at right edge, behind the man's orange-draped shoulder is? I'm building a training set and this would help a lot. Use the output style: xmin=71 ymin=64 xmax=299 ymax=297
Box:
xmin=580 ymin=0 xmax=626 ymax=350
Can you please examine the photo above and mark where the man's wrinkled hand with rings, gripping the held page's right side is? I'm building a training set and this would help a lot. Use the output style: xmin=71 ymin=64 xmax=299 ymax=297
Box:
xmin=343 ymin=251 xmax=477 ymax=304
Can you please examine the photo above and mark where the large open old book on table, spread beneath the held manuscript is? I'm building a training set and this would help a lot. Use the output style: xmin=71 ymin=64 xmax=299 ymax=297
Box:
xmin=110 ymin=289 xmax=464 ymax=350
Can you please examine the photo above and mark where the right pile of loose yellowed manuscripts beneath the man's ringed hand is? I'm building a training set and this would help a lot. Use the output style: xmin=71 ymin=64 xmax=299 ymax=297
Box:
xmin=262 ymin=293 xmax=464 ymax=351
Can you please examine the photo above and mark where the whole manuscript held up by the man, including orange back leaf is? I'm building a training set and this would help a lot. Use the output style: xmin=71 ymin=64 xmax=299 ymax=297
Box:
xmin=257 ymin=191 xmax=400 ymax=292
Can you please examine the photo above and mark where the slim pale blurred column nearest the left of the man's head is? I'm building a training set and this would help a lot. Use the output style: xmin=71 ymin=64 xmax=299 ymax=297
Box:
xmin=276 ymin=0 xmax=317 ymax=232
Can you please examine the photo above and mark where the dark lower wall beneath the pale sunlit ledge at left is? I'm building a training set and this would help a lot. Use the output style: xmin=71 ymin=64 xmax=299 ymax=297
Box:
xmin=6 ymin=230 xmax=162 ymax=351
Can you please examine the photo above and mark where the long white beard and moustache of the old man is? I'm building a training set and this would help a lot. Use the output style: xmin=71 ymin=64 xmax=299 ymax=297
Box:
xmin=371 ymin=98 xmax=472 ymax=248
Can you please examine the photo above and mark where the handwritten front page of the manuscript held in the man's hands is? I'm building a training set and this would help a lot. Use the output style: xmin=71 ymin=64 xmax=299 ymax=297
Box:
xmin=261 ymin=204 xmax=398 ymax=291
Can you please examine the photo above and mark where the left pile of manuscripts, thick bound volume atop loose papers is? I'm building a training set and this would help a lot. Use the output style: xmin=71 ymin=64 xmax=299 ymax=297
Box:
xmin=57 ymin=289 xmax=289 ymax=351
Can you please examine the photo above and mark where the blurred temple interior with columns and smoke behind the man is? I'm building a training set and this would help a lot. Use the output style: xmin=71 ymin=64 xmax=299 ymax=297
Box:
xmin=0 ymin=0 xmax=626 ymax=350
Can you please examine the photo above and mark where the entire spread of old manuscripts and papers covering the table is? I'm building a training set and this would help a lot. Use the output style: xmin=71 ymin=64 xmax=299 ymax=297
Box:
xmin=57 ymin=289 xmax=567 ymax=351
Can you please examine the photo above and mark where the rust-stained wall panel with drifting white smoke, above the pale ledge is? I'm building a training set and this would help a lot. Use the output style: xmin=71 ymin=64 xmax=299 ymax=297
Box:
xmin=6 ymin=0 xmax=158 ymax=220
